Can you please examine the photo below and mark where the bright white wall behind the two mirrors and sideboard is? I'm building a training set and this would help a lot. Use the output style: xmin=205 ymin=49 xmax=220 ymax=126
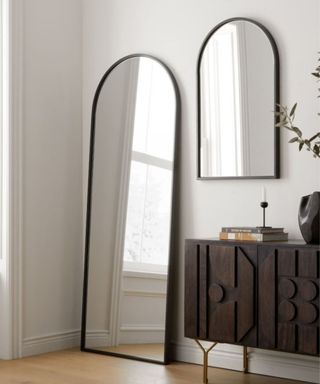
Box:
xmin=83 ymin=0 xmax=320 ymax=381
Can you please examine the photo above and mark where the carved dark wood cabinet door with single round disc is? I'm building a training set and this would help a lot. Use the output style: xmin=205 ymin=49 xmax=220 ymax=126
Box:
xmin=185 ymin=242 xmax=257 ymax=347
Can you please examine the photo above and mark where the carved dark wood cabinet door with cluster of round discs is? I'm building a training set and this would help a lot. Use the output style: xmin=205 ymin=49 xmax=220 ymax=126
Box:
xmin=258 ymin=247 xmax=320 ymax=355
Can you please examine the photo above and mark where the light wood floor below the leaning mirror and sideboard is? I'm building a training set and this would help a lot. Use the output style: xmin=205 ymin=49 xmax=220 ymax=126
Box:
xmin=0 ymin=350 xmax=301 ymax=384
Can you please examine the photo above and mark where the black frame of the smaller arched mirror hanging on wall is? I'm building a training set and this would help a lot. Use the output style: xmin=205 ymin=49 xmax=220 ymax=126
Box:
xmin=197 ymin=17 xmax=280 ymax=180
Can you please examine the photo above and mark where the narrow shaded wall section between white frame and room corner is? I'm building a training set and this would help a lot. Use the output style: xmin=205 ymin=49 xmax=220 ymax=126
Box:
xmin=15 ymin=0 xmax=83 ymax=355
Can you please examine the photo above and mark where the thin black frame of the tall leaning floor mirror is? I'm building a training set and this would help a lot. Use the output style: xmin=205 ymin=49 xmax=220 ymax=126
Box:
xmin=80 ymin=53 xmax=181 ymax=365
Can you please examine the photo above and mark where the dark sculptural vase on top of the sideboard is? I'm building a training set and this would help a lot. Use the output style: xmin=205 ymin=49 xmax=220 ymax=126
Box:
xmin=299 ymin=192 xmax=320 ymax=244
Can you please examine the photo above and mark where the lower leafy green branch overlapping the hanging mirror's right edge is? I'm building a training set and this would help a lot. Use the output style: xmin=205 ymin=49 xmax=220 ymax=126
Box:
xmin=276 ymin=103 xmax=320 ymax=158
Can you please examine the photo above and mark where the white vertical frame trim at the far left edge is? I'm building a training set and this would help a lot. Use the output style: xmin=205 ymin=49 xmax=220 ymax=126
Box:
xmin=0 ymin=0 xmax=23 ymax=359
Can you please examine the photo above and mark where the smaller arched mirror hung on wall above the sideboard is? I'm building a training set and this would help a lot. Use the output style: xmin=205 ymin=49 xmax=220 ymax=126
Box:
xmin=198 ymin=18 xmax=279 ymax=179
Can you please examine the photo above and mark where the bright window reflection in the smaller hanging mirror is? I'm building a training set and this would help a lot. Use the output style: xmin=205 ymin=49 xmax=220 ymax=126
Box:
xmin=201 ymin=23 xmax=244 ymax=176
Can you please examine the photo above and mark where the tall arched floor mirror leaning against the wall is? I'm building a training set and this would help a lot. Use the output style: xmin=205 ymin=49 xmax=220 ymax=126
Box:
xmin=81 ymin=55 xmax=180 ymax=363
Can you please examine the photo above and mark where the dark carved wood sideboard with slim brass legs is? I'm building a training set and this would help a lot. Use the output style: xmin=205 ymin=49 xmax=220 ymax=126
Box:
xmin=185 ymin=239 xmax=320 ymax=383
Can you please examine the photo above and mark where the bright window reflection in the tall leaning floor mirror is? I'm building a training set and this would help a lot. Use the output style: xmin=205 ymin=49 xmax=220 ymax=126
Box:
xmin=124 ymin=60 xmax=175 ymax=273
